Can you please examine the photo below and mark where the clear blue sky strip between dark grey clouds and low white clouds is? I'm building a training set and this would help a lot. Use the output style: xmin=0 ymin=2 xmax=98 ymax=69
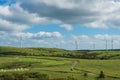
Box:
xmin=25 ymin=24 xmax=120 ymax=36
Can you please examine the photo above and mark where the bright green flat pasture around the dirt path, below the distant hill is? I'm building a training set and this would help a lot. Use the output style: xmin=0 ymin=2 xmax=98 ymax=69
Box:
xmin=0 ymin=56 xmax=120 ymax=80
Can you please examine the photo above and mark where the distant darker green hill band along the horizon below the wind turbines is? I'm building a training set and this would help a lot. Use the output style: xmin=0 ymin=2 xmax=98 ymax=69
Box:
xmin=0 ymin=46 xmax=120 ymax=59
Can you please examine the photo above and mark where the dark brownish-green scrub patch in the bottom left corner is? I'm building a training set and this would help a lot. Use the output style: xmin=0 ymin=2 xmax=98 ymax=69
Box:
xmin=0 ymin=72 xmax=49 ymax=80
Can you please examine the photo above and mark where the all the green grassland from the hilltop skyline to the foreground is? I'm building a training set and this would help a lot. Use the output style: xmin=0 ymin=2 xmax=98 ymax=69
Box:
xmin=0 ymin=47 xmax=120 ymax=80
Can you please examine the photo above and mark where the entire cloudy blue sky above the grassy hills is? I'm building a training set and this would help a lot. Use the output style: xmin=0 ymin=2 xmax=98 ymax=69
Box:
xmin=0 ymin=0 xmax=120 ymax=50
